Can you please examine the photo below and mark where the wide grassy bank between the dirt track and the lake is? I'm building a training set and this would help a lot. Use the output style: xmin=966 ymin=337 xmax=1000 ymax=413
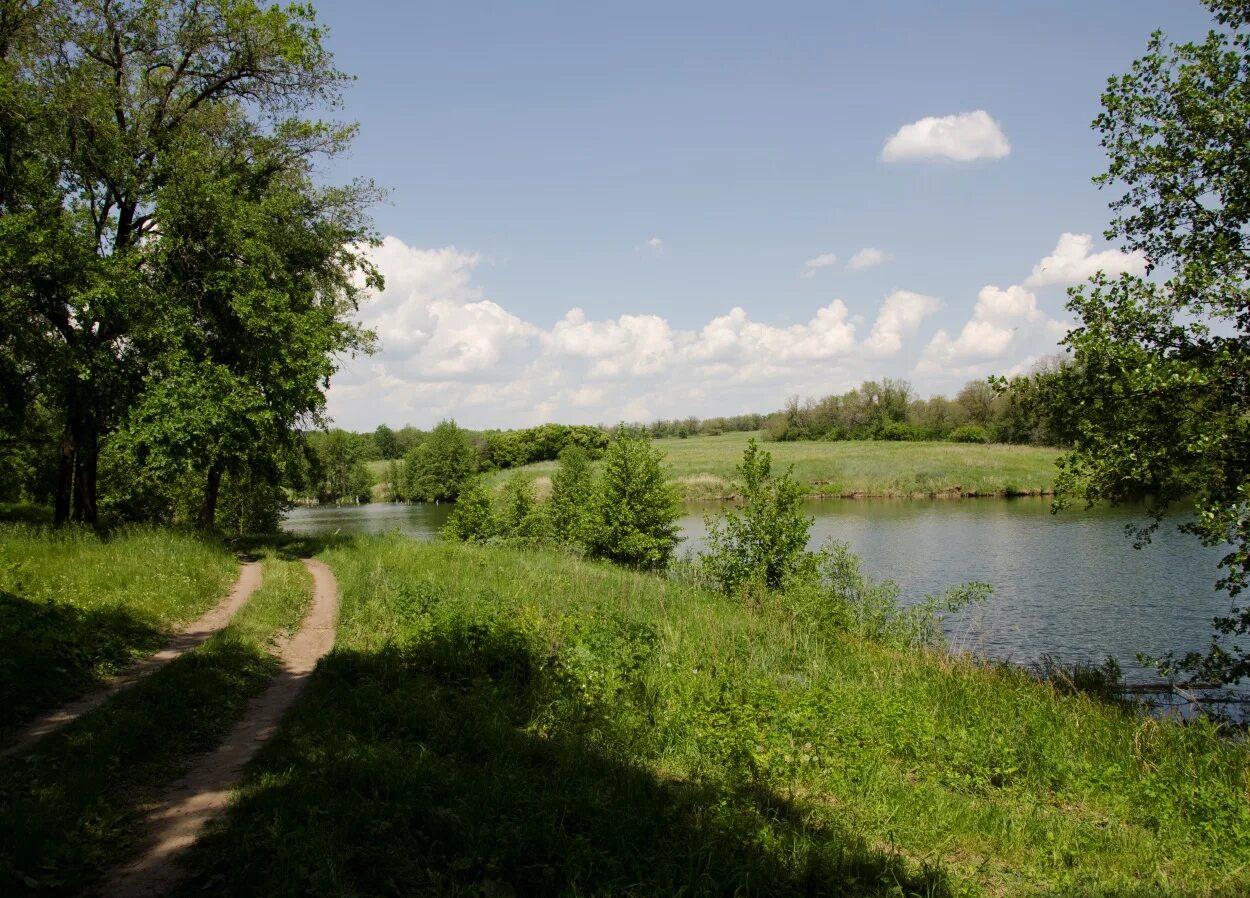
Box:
xmin=183 ymin=538 xmax=1250 ymax=895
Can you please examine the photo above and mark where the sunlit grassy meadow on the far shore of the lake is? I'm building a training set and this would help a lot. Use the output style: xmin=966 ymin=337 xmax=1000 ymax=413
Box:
xmin=472 ymin=433 xmax=1059 ymax=499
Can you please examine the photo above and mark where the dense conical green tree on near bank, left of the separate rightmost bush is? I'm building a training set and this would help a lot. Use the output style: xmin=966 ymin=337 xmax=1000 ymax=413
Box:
xmin=586 ymin=424 xmax=681 ymax=570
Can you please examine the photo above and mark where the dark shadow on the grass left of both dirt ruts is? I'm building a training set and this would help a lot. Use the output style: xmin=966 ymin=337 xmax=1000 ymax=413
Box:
xmin=0 ymin=590 xmax=169 ymax=744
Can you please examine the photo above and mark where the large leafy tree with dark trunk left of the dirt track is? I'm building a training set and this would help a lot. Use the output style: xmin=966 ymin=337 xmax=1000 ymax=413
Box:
xmin=0 ymin=0 xmax=374 ymax=523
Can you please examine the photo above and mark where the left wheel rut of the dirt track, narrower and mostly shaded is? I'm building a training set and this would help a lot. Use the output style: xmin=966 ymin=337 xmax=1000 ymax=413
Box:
xmin=0 ymin=562 xmax=260 ymax=759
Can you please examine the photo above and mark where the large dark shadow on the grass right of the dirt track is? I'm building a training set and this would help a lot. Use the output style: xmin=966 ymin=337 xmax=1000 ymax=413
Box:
xmin=180 ymin=623 xmax=950 ymax=898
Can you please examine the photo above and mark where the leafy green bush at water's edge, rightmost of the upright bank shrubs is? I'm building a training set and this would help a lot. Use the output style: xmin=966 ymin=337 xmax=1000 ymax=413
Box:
xmin=700 ymin=440 xmax=813 ymax=593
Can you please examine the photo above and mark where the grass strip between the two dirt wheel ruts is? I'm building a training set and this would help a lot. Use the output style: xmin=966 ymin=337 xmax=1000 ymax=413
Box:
xmin=0 ymin=555 xmax=311 ymax=895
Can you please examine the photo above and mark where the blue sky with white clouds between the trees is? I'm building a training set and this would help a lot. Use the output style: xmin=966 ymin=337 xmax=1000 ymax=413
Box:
xmin=307 ymin=0 xmax=1210 ymax=430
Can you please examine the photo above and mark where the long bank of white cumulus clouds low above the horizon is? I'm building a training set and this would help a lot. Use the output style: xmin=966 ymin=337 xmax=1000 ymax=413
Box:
xmin=328 ymin=238 xmax=1066 ymax=429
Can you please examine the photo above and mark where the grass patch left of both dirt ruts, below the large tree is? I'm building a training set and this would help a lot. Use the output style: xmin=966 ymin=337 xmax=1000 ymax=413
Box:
xmin=0 ymin=524 xmax=239 ymax=738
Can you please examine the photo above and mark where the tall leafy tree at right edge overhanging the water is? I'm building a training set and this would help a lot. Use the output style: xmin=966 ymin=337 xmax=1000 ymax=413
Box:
xmin=1049 ymin=0 xmax=1250 ymax=682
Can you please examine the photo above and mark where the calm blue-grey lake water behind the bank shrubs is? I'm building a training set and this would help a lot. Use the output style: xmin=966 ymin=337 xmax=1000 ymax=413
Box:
xmin=284 ymin=498 xmax=1229 ymax=680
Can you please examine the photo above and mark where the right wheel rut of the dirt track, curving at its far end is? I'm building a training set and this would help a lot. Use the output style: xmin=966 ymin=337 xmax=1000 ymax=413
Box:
xmin=104 ymin=560 xmax=339 ymax=898
